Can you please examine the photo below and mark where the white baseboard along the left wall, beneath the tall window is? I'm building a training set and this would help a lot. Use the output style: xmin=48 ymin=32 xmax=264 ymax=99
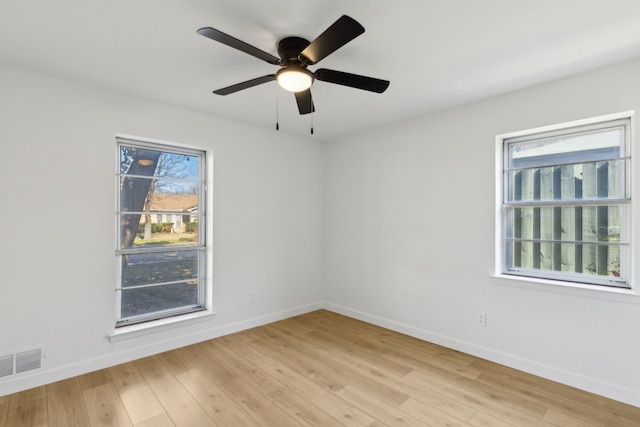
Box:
xmin=0 ymin=303 xmax=324 ymax=396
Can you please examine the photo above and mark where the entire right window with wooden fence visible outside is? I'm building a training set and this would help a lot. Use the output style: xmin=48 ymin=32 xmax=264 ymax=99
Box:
xmin=497 ymin=113 xmax=631 ymax=288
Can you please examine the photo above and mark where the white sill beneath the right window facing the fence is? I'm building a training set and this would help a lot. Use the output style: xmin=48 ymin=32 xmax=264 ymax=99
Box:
xmin=491 ymin=274 xmax=640 ymax=304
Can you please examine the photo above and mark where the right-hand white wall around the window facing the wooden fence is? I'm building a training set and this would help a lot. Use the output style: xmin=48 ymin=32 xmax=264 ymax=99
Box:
xmin=325 ymin=57 xmax=640 ymax=406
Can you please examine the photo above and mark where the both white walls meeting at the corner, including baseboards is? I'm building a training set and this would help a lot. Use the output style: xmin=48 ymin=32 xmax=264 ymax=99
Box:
xmin=0 ymin=56 xmax=640 ymax=406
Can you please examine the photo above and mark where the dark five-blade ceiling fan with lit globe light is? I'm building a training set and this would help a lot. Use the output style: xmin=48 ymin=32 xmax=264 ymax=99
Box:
xmin=198 ymin=15 xmax=389 ymax=114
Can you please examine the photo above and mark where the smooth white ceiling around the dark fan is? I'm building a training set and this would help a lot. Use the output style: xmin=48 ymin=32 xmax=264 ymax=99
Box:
xmin=0 ymin=0 xmax=640 ymax=140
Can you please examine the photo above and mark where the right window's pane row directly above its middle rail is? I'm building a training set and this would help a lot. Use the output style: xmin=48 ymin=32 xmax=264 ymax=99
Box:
xmin=508 ymin=160 xmax=625 ymax=202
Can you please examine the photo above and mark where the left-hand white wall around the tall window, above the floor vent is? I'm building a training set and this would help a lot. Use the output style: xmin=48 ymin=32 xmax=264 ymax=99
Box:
xmin=0 ymin=67 xmax=324 ymax=395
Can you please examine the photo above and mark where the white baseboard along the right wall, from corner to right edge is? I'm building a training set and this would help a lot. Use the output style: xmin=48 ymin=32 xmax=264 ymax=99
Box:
xmin=324 ymin=303 xmax=640 ymax=407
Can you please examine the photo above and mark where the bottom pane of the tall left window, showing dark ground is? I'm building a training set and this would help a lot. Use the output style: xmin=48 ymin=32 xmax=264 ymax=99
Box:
xmin=120 ymin=281 xmax=199 ymax=318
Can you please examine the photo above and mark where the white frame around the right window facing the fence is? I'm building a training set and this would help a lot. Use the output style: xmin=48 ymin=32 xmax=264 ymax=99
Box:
xmin=494 ymin=111 xmax=640 ymax=296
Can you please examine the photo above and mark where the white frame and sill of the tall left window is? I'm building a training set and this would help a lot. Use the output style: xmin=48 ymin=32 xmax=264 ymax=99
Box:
xmin=108 ymin=135 xmax=215 ymax=342
